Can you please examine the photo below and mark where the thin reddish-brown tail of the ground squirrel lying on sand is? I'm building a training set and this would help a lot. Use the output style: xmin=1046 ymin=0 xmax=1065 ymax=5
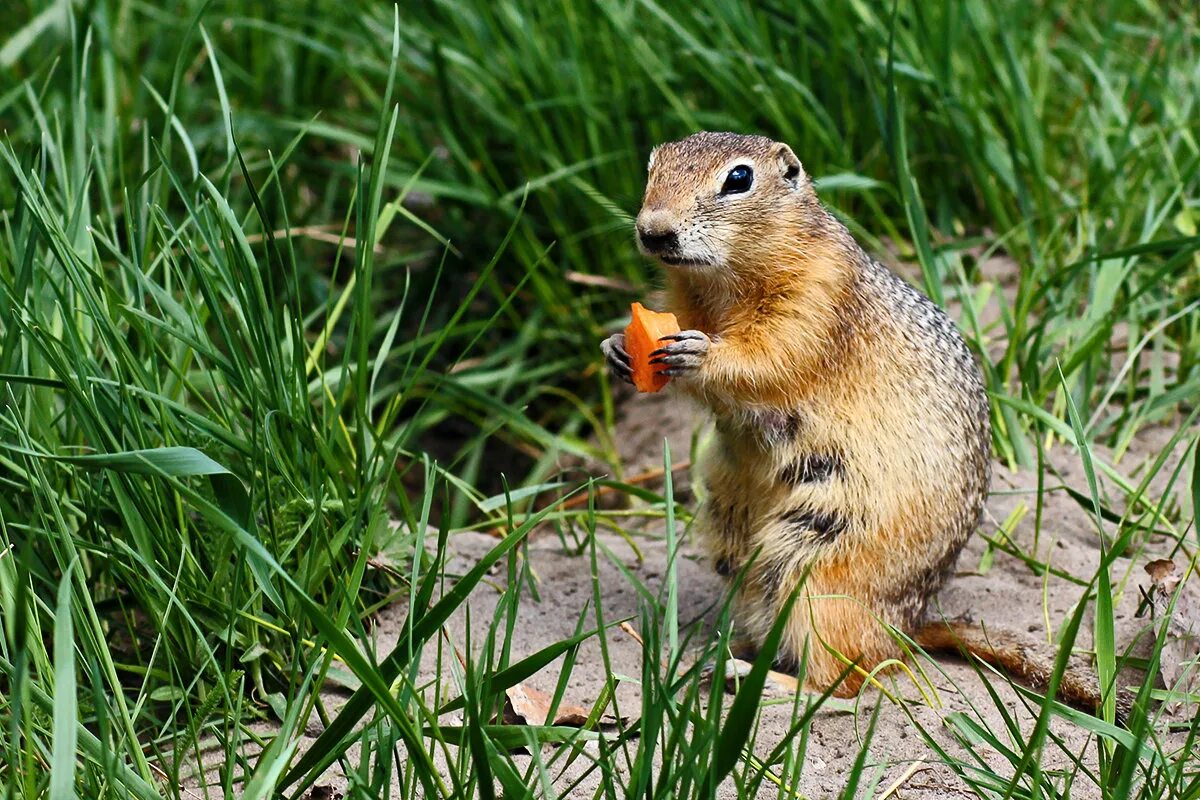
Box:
xmin=912 ymin=620 xmax=1132 ymax=723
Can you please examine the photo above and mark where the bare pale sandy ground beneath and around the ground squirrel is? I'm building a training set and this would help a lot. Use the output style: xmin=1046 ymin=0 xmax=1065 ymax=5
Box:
xmin=182 ymin=260 xmax=1200 ymax=800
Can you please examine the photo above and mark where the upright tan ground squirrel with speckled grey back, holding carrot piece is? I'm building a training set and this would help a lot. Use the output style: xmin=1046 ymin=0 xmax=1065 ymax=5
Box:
xmin=601 ymin=132 xmax=1113 ymax=708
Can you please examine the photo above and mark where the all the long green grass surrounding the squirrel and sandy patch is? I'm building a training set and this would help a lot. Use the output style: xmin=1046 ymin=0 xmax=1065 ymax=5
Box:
xmin=0 ymin=0 xmax=1200 ymax=798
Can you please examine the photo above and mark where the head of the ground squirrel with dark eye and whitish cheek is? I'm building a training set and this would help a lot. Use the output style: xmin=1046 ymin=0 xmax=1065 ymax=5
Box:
xmin=637 ymin=132 xmax=823 ymax=279
